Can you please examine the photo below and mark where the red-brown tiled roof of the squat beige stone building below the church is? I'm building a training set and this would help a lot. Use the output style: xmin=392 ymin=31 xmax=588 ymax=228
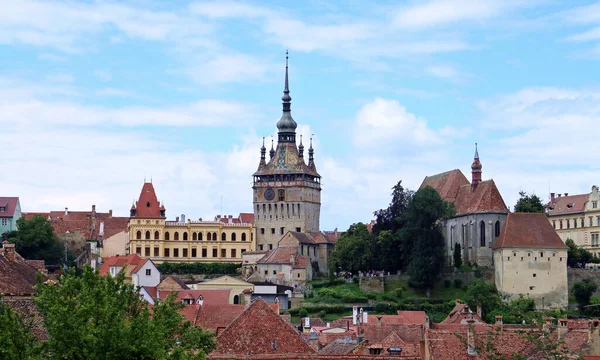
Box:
xmin=494 ymin=213 xmax=567 ymax=249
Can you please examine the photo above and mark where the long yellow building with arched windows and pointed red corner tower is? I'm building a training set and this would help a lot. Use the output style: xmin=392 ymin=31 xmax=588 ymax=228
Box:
xmin=128 ymin=183 xmax=256 ymax=263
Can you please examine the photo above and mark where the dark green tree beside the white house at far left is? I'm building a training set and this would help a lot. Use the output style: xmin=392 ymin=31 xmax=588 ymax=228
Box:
xmin=8 ymin=215 xmax=64 ymax=265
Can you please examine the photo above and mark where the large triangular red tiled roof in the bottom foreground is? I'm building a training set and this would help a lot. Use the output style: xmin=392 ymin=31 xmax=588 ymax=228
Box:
xmin=214 ymin=298 xmax=315 ymax=355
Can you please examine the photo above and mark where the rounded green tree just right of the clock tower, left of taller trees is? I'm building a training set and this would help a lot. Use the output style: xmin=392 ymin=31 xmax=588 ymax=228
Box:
xmin=331 ymin=223 xmax=373 ymax=273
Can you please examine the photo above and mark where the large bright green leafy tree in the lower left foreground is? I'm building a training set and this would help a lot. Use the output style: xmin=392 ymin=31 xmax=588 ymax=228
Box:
xmin=34 ymin=267 xmax=215 ymax=359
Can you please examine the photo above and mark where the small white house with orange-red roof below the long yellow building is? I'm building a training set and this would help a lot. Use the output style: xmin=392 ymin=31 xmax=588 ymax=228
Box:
xmin=100 ymin=254 xmax=160 ymax=287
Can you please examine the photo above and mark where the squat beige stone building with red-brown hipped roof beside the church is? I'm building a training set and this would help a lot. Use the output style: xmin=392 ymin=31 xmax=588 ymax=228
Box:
xmin=494 ymin=213 xmax=568 ymax=309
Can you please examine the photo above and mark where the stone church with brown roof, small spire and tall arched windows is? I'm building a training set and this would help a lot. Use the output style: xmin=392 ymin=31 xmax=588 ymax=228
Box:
xmin=419 ymin=144 xmax=509 ymax=266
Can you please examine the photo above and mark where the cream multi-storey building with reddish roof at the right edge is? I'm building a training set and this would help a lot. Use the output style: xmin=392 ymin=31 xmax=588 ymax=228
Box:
xmin=546 ymin=185 xmax=600 ymax=256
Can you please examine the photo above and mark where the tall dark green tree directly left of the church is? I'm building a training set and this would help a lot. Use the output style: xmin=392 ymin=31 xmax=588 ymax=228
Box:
xmin=400 ymin=186 xmax=453 ymax=296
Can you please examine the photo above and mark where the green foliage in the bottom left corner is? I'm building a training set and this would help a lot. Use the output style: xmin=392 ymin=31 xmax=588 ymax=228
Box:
xmin=0 ymin=299 xmax=43 ymax=360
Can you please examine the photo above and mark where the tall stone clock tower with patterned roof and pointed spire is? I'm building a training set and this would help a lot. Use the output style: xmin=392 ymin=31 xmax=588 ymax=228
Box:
xmin=252 ymin=52 xmax=321 ymax=250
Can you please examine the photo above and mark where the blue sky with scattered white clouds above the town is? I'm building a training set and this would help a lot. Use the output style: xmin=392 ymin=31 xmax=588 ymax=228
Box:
xmin=0 ymin=0 xmax=600 ymax=230
